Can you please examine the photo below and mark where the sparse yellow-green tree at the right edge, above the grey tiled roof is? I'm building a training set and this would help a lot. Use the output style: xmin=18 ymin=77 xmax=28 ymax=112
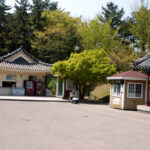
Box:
xmin=131 ymin=0 xmax=150 ymax=52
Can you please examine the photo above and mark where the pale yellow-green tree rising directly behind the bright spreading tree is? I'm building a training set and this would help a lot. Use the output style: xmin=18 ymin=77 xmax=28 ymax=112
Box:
xmin=80 ymin=18 xmax=118 ymax=52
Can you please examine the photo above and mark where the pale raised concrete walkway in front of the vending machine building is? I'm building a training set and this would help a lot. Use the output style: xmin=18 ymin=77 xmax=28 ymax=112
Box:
xmin=0 ymin=96 xmax=68 ymax=102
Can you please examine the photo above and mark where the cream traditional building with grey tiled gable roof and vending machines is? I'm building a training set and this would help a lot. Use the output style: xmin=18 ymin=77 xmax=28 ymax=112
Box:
xmin=0 ymin=47 xmax=52 ymax=96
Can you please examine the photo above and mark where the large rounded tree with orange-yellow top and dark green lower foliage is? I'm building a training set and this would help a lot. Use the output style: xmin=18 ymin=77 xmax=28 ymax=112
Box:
xmin=32 ymin=10 xmax=80 ymax=63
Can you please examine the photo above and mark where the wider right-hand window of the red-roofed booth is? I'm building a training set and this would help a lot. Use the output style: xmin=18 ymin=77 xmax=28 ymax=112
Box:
xmin=127 ymin=83 xmax=143 ymax=98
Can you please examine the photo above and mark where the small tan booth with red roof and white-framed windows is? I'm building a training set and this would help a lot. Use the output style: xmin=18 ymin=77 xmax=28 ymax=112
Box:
xmin=107 ymin=70 xmax=147 ymax=110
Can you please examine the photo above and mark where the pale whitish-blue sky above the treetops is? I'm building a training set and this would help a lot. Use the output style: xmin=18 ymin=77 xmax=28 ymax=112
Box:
xmin=6 ymin=0 xmax=143 ymax=19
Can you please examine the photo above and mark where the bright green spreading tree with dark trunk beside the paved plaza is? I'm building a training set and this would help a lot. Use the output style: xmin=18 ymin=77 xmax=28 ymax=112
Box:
xmin=51 ymin=49 xmax=115 ymax=99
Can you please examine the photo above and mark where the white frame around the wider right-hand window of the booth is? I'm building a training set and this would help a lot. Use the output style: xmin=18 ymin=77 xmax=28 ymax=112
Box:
xmin=127 ymin=82 xmax=143 ymax=99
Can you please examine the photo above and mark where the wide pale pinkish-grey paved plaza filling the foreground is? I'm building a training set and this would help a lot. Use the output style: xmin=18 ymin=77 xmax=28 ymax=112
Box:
xmin=0 ymin=101 xmax=150 ymax=150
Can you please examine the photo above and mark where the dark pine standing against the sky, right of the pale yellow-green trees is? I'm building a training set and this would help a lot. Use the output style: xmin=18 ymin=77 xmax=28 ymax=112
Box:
xmin=99 ymin=2 xmax=135 ymax=45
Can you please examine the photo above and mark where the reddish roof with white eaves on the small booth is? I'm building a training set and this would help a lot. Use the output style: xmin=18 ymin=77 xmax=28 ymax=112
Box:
xmin=108 ymin=70 xmax=147 ymax=79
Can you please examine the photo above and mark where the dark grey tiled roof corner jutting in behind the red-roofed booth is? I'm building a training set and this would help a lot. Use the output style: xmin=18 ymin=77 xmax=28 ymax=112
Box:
xmin=132 ymin=53 xmax=150 ymax=71
